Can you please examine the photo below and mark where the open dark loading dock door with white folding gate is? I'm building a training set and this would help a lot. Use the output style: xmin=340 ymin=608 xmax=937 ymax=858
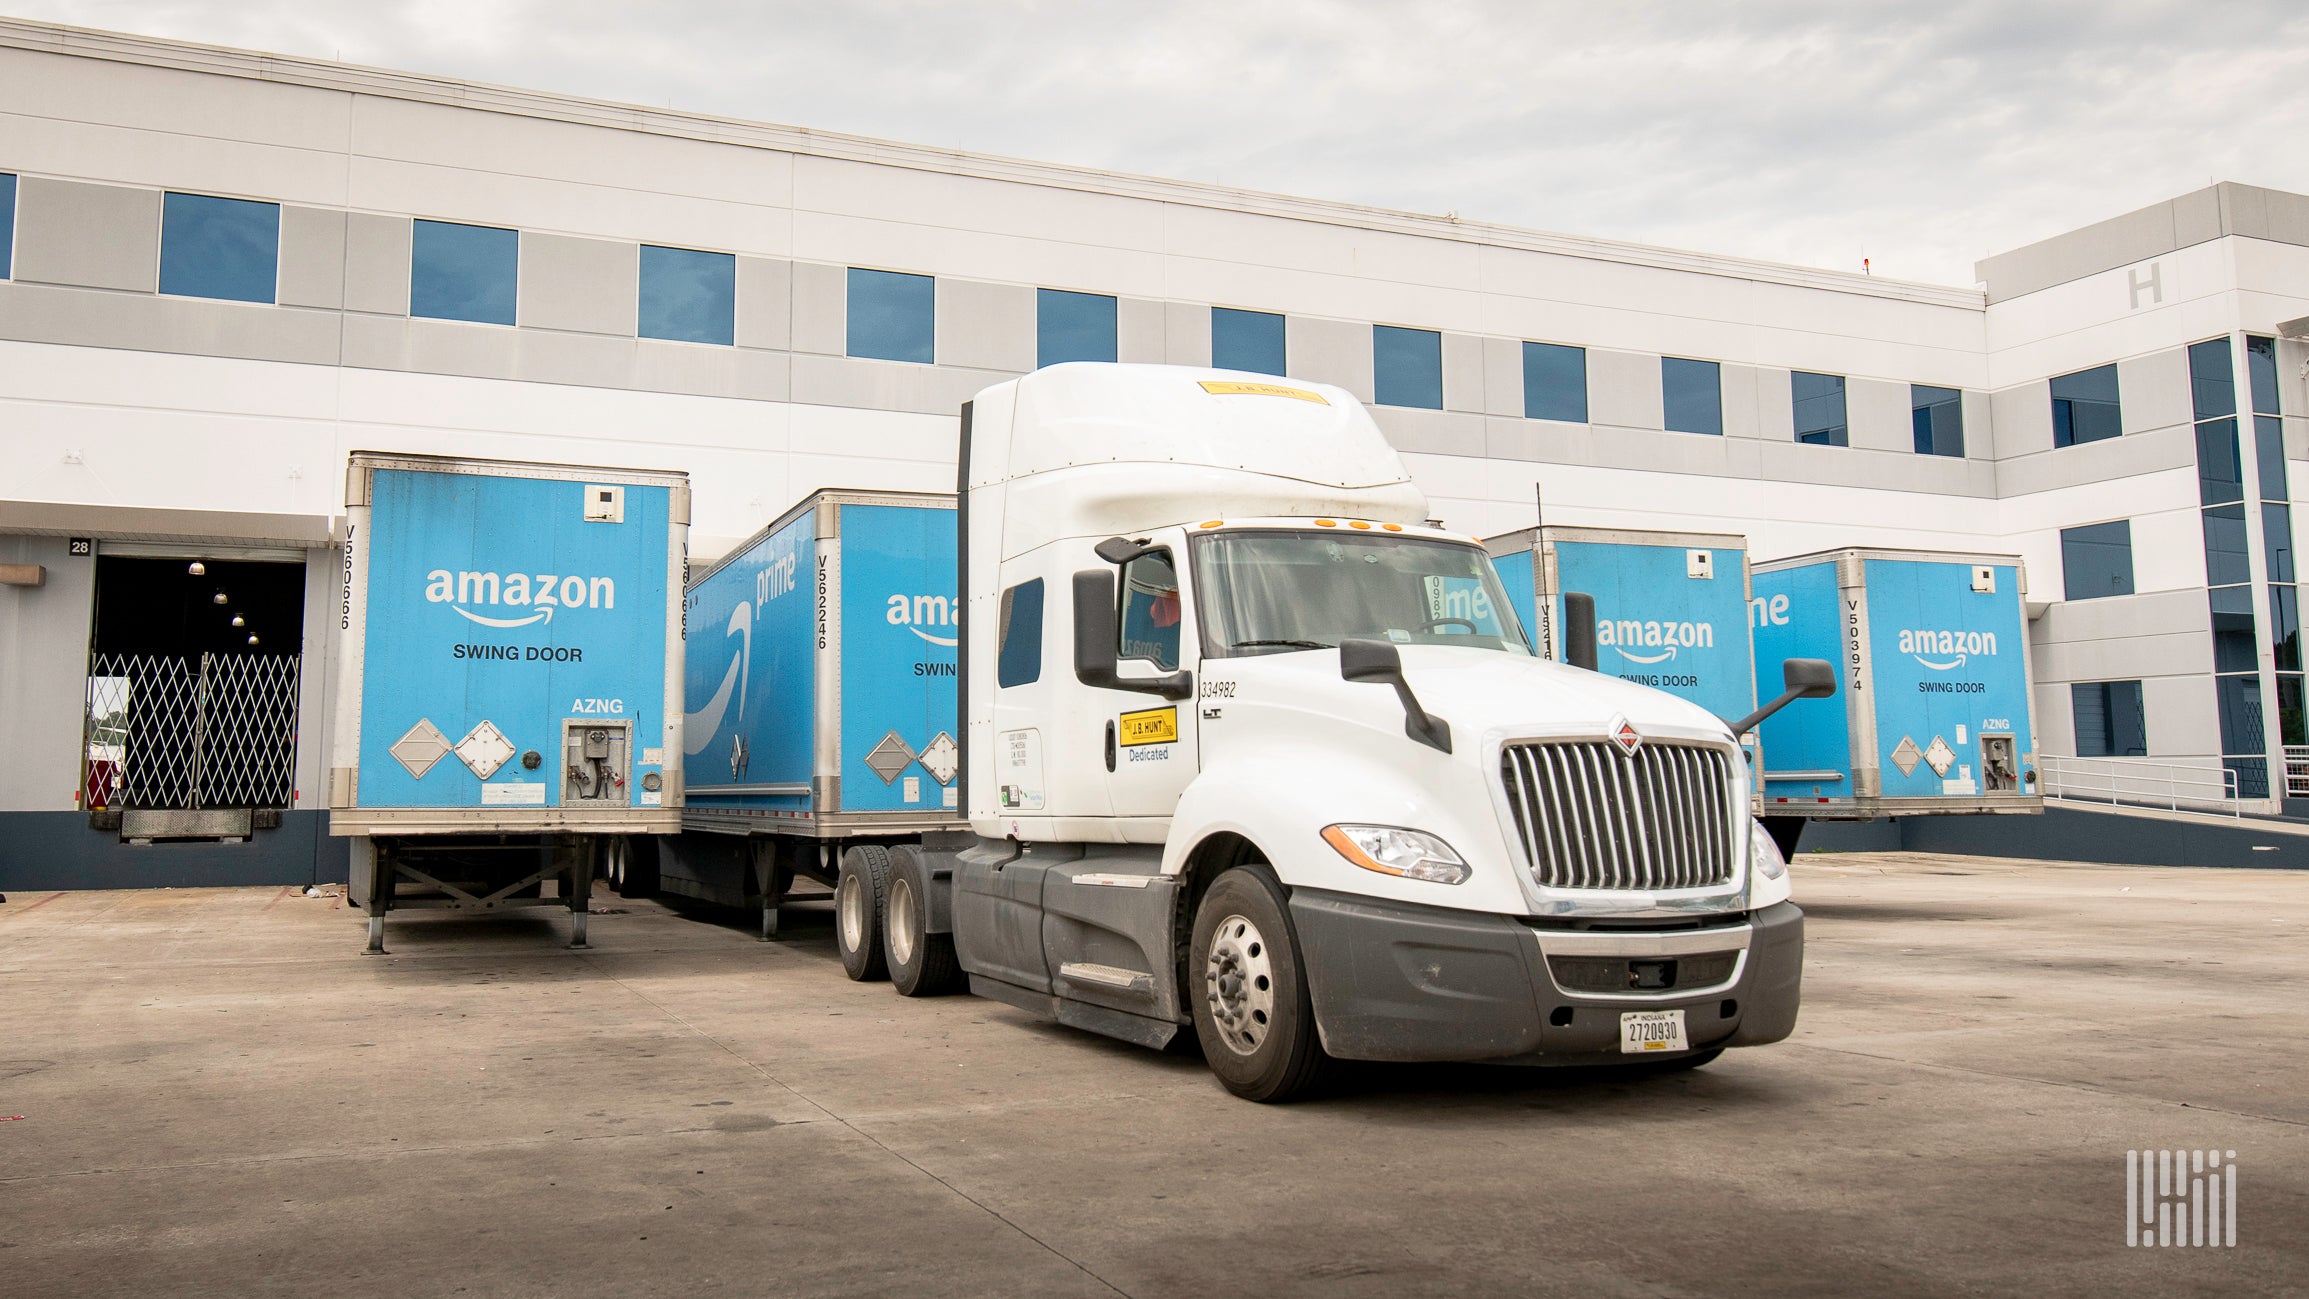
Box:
xmin=83 ymin=554 xmax=305 ymax=821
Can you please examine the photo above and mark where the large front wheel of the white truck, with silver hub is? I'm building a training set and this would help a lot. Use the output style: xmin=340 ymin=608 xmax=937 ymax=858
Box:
xmin=1187 ymin=865 xmax=1330 ymax=1103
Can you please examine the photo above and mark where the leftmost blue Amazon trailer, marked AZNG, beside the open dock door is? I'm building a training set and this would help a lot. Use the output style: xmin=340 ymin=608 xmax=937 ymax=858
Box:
xmin=328 ymin=452 xmax=690 ymax=953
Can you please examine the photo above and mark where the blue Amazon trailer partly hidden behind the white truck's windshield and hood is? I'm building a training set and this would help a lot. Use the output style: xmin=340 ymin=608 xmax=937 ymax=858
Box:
xmin=1482 ymin=526 xmax=1757 ymax=722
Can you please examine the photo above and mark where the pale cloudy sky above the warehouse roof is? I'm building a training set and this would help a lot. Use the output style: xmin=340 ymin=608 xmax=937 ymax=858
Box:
xmin=18 ymin=0 xmax=2309 ymax=284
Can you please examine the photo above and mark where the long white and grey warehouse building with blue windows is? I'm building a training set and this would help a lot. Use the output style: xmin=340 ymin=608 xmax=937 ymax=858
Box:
xmin=0 ymin=21 xmax=2309 ymax=888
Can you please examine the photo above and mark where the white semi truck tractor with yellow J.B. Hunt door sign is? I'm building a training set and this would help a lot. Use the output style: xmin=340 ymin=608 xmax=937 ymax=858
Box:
xmin=836 ymin=365 xmax=1833 ymax=1101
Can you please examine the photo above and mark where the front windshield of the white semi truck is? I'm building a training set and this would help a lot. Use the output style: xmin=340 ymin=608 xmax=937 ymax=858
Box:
xmin=1194 ymin=528 xmax=1531 ymax=658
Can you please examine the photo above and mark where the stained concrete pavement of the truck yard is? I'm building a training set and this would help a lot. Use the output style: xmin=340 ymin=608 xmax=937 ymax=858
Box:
xmin=0 ymin=854 xmax=2309 ymax=1297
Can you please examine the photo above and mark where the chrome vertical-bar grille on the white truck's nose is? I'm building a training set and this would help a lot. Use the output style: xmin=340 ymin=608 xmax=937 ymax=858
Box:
xmin=1499 ymin=741 xmax=1739 ymax=891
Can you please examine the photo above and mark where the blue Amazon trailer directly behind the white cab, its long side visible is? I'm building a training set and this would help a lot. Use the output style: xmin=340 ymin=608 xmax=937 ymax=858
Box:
xmin=653 ymin=491 xmax=965 ymax=937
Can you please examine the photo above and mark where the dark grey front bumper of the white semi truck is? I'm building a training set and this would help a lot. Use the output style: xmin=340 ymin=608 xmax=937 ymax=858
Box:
xmin=1291 ymin=888 xmax=1803 ymax=1064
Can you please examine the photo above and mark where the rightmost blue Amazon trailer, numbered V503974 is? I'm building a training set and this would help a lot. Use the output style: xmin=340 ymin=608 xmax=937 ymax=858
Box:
xmin=1755 ymin=549 xmax=2043 ymax=819
